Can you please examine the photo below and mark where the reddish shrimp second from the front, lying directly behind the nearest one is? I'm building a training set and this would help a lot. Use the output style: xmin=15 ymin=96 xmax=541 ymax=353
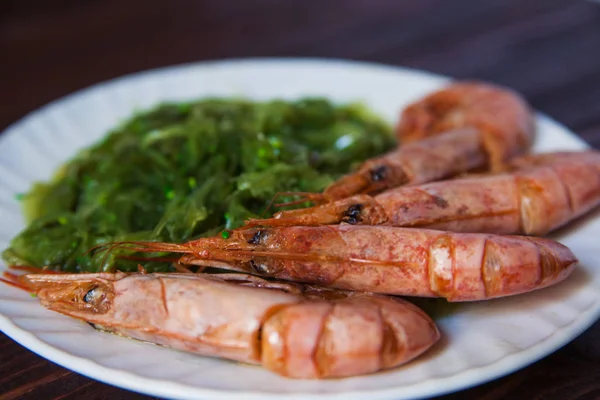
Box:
xmin=107 ymin=224 xmax=577 ymax=301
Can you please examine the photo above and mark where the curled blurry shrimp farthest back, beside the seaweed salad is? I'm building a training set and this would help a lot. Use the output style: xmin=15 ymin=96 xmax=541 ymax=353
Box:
xmin=288 ymin=82 xmax=535 ymax=204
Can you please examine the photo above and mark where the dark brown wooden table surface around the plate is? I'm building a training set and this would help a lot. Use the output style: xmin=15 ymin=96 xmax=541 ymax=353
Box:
xmin=0 ymin=0 xmax=600 ymax=400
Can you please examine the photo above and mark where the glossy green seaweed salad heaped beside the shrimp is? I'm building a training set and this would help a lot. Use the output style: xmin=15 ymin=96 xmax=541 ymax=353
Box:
xmin=2 ymin=98 xmax=394 ymax=272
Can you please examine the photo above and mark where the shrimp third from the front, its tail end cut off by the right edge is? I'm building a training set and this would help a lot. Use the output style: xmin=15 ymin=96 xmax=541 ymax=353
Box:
xmin=246 ymin=151 xmax=600 ymax=236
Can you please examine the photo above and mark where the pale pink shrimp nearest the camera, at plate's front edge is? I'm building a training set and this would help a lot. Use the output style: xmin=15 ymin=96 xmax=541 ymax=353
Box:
xmin=21 ymin=273 xmax=440 ymax=379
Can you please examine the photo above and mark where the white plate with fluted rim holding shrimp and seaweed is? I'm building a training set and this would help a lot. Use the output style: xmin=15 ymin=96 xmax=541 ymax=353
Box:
xmin=0 ymin=60 xmax=600 ymax=399
